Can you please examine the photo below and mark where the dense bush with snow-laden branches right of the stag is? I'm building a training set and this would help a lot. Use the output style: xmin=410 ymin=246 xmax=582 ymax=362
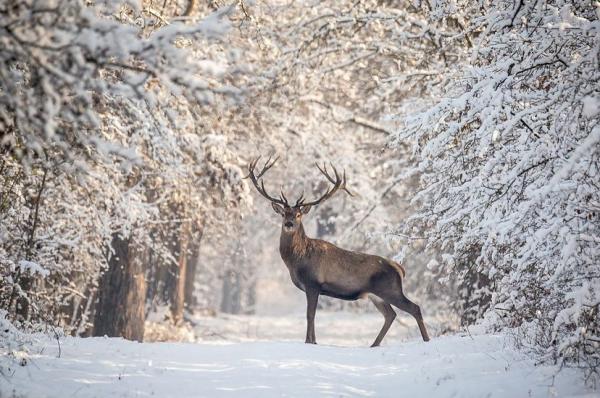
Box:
xmin=395 ymin=0 xmax=600 ymax=386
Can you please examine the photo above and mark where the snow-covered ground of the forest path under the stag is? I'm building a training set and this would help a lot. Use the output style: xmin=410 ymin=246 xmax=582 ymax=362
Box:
xmin=0 ymin=313 xmax=597 ymax=398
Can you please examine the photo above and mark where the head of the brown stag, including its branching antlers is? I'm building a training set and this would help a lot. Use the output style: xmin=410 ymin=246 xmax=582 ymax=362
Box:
xmin=246 ymin=156 xmax=352 ymax=232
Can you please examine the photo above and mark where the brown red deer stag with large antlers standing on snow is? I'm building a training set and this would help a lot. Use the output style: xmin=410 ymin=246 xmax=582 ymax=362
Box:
xmin=246 ymin=157 xmax=429 ymax=347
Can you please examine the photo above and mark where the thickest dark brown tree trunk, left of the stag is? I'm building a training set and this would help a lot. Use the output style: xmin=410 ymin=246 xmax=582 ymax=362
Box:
xmin=93 ymin=234 xmax=146 ymax=341
